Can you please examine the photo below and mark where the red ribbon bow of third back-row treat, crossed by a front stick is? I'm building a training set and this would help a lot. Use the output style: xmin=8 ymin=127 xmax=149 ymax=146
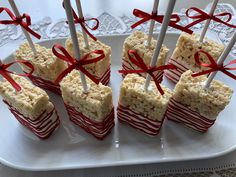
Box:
xmin=131 ymin=9 xmax=193 ymax=34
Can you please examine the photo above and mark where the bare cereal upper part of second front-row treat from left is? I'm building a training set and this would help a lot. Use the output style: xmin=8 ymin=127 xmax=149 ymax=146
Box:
xmin=60 ymin=70 xmax=113 ymax=122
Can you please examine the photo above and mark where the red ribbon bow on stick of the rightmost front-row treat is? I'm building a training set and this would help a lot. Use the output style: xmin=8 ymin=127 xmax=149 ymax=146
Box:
xmin=192 ymin=51 xmax=236 ymax=80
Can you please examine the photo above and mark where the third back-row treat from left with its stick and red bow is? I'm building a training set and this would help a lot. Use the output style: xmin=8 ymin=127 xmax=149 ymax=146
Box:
xmin=122 ymin=0 xmax=192 ymax=82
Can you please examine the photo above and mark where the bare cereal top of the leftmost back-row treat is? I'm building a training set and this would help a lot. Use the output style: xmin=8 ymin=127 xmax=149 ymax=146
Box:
xmin=15 ymin=43 xmax=67 ymax=82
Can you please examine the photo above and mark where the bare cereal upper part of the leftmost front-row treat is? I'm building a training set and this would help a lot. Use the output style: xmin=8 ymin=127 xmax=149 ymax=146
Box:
xmin=0 ymin=75 xmax=54 ymax=120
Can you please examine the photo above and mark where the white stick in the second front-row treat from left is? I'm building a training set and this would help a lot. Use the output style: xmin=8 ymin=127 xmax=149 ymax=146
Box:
xmin=64 ymin=0 xmax=88 ymax=92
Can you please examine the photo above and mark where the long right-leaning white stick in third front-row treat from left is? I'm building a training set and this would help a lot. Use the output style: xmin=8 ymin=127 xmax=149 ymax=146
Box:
xmin=144 ymin=0 xmax=176 ymax=91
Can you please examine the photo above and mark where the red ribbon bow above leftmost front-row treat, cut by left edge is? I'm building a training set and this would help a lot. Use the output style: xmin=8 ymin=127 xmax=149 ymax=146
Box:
xmin=0 ymin=60 xmax=34 ymax=91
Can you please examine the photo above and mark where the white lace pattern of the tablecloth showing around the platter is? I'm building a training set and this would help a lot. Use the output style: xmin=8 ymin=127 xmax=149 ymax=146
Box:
xmin=0 ymin=3 xmax=236 ymax=177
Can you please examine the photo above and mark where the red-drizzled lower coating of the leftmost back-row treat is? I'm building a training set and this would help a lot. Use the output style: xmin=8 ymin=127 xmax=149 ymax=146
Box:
xmin=25 ymin=75 xmax=61 ymax=95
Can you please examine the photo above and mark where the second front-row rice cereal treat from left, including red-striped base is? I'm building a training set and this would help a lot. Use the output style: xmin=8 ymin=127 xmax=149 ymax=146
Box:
xmin=60 ymin=70 xmax=114 ymax=139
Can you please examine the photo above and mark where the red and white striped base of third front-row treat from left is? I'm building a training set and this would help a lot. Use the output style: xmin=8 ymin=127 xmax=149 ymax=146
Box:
xmin=117 ymin=104 xmax=164 ymax=136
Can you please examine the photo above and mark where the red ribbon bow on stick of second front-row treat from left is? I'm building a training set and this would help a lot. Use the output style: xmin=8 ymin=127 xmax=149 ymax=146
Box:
xmin=52 ymin=44 xmax=105 ymax=84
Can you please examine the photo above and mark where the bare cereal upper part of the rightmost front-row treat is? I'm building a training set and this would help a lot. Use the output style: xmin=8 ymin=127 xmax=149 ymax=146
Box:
xmin=173 ymin=70 xmax=233 ymax=120
